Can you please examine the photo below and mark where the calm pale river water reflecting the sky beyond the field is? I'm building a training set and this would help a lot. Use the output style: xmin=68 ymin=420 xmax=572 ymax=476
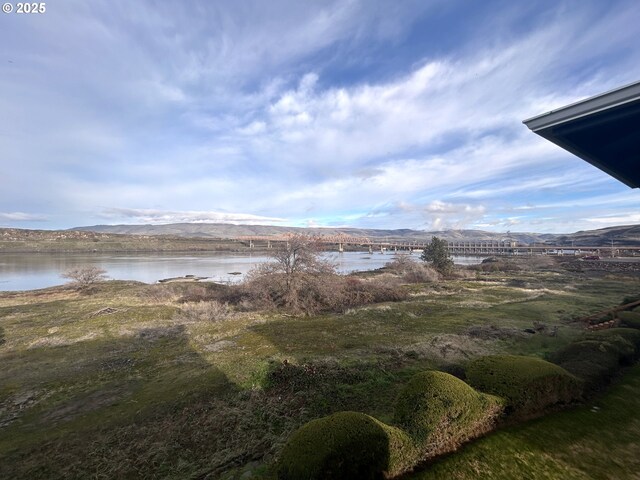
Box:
xmin=0 ymin=252 xmax=482 ymax=291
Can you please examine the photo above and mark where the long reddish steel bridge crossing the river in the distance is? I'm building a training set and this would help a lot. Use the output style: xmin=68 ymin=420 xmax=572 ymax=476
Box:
xmin=234 ymin=234 xmax=640 ymax=257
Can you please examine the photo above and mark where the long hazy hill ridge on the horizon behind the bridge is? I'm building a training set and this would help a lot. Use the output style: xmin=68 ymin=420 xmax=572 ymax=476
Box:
xmin=72 ymin=223 xmax=640 ymax=246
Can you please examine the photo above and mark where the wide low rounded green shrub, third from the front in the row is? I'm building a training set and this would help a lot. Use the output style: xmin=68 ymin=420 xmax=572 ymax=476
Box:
xmin=466 ymin=355 xmax=582 ymax=416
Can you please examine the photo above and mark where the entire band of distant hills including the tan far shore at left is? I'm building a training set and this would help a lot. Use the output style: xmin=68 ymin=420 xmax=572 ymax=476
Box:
xmin=0 ymin=223 xmax=640 ymax=252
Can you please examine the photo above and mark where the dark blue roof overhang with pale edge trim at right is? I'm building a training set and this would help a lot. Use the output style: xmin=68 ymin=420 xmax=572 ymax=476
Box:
xmin=523 ymin=82 xmax=640 ymax=188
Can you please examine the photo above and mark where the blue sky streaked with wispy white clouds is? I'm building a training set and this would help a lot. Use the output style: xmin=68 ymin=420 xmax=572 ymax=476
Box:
xmin=0 ymin=0 xmax=640 ymax=233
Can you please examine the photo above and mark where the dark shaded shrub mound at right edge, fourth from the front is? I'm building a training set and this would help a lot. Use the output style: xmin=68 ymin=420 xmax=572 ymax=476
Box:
xmin=551 ymin=328 xmax=640 ymax=390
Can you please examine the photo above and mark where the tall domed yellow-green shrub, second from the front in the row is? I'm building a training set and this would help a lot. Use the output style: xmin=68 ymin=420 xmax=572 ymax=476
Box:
xmin=395 ymin=371 xmax=502 ymax=448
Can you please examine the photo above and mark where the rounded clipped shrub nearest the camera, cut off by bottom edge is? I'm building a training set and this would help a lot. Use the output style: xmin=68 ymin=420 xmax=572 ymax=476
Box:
xmin=278 ymin=412 xmax=417 ymax=480
